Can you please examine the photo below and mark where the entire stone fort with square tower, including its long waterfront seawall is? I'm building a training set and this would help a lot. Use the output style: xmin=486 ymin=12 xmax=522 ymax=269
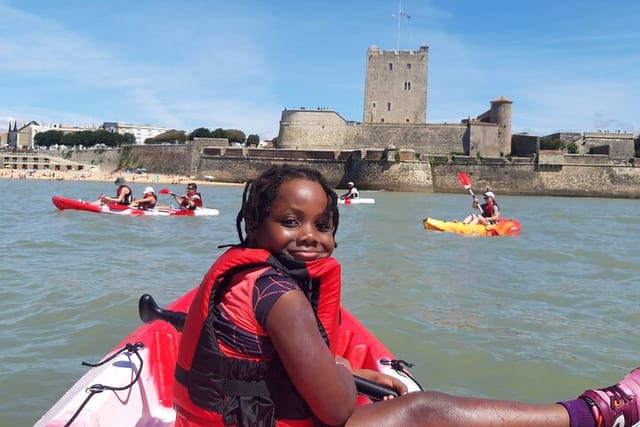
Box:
xmin=52 ymin=46 xmax=640 ymax=198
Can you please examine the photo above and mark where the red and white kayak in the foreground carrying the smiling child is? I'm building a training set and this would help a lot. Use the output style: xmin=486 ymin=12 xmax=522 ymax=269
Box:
xmin=35 ymin=288 xmax=420 ymax=427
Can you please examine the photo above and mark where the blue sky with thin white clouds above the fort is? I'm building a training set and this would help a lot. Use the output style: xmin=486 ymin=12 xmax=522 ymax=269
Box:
xmin=0 ymin=0 xmax=640 ymax=140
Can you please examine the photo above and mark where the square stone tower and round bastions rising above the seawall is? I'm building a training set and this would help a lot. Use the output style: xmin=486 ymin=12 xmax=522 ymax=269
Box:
xmin=276 ymin=46 xmax=512 ymax=157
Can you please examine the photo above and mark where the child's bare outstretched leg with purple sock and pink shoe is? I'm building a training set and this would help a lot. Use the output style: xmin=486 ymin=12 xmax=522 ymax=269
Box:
xmin=346 ymin=368 xmax=640 ymax=427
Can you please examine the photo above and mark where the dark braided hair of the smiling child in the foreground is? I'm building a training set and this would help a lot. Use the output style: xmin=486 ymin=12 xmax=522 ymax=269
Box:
xmin=236 ymin=164 xmax=340 ymax=247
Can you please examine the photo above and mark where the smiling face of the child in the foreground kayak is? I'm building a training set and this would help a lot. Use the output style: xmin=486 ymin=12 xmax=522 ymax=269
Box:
xmin=253 ymin=178 xmax=335 ymax=261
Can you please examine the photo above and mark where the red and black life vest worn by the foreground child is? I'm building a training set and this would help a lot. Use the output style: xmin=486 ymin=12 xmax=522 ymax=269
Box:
xmin=173 ymin=247 xmax=340 ymax=426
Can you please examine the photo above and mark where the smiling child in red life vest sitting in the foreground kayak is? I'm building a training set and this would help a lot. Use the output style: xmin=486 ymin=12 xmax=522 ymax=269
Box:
xmin=173 ymin=165 xmax=640 ymax=427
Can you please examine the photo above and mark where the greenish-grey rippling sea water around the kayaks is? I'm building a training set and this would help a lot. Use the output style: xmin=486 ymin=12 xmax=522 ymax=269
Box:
xmin=0 ymin=179 xmax=640 ymax=426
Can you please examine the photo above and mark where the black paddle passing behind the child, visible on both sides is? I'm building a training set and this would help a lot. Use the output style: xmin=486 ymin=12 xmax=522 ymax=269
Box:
xmin=138 ymin=294 xmax=398 ymax=400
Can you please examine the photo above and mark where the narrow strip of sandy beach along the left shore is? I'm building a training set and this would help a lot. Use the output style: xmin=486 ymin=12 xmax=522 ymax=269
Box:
xmin=0 ymin=166 xmax=244 ymax=186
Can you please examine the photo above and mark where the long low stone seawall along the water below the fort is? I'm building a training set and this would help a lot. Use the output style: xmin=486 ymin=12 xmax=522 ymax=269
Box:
xmin=62 ymin=141 xmax=640 ymax=199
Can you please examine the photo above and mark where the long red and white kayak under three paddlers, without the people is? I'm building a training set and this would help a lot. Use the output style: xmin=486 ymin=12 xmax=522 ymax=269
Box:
xmin=51 ymin=196 xmax=220 ymax=216
